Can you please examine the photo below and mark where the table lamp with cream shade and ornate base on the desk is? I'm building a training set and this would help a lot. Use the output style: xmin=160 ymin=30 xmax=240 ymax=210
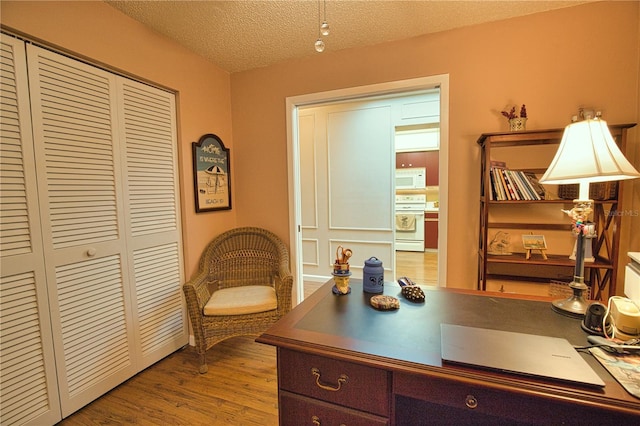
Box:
xmin=540 ymin=117 xmax=640 ymax=317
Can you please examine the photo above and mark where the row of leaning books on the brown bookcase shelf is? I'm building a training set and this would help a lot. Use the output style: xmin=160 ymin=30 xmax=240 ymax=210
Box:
xmin=489 ymin=165 xmax=545 ymax=201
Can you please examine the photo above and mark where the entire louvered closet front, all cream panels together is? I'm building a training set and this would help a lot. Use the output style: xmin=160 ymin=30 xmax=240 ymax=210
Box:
xmin=0 ymin=34 xmax=188 ymax=426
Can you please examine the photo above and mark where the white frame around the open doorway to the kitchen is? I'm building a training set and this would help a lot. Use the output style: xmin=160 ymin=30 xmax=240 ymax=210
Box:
xmin=286 ymin=74 xmax=449 ymax=304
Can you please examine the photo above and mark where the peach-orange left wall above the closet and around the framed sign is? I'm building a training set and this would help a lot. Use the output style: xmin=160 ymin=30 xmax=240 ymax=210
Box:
xmin=1 ymin=0 xmax=237 ymax=278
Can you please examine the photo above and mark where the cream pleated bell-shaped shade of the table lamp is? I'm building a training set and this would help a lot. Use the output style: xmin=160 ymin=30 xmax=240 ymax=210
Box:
xmin=540 ymin=118 xmax=640 ymax=195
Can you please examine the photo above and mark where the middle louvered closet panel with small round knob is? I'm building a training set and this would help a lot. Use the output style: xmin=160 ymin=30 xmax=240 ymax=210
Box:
xmin=27 ymin=45 xmax=136 ymax=417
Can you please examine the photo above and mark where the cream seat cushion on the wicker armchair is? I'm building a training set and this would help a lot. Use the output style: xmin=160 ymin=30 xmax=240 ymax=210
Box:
xmin=204 ymin=285 xmax=278 ymax=315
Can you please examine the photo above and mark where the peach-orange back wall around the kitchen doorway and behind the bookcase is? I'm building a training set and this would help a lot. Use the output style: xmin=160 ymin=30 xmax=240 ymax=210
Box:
xmin=231 ymin=2 xmax=640 ymax=288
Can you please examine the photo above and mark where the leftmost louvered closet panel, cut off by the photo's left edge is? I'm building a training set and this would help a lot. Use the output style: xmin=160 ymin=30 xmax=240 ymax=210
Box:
xmin=0 ymin=34 xmax=61 ymax=425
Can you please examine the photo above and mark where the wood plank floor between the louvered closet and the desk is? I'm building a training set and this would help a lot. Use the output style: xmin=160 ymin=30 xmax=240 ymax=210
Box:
xmin=59 ymin=337 xmax=278 ymax=426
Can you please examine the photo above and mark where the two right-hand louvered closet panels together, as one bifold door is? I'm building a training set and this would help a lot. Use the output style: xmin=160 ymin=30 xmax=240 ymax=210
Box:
xmin=27 ymin=45 xmax=188 ymax=417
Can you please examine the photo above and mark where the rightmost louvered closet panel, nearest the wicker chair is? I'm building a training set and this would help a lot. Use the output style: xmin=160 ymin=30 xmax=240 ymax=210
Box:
xmin=117 ymin=78 xmax=189 ymax=369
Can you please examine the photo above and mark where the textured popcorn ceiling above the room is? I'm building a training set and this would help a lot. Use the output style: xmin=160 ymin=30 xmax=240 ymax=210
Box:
xmin=105 ymin=0 xmax=589 ymax=72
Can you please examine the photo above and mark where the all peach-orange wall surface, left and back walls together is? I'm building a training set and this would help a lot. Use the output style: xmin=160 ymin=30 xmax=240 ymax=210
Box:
xmin=1 ymin=1 xmax=640 ymax=287
